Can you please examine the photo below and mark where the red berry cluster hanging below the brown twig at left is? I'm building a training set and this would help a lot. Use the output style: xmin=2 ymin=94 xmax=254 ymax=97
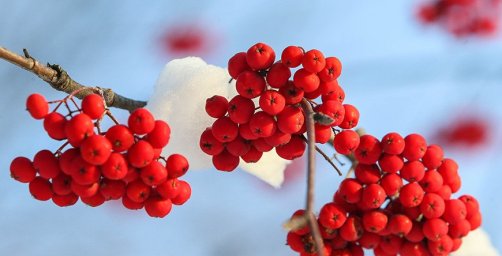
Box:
xmin=10 ymin=90 xmax=191 ymax=217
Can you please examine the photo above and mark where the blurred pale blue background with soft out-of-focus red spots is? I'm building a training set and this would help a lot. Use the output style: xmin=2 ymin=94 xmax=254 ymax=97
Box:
xmin=0 ymin=0 xmax=502 ymax=256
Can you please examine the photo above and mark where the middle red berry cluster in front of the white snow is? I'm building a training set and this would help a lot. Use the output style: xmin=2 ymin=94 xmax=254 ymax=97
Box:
xmin=200 ymin=43 xmax=359 ymax=171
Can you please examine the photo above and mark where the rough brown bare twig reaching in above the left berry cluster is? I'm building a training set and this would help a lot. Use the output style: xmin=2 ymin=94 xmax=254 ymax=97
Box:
xmin=0 ymin=46 xmax=146 ymax=111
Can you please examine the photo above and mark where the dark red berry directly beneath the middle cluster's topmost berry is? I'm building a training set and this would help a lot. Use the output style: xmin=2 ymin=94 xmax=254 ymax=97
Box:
xmin=235 ymin=71 xmax=266 ymax=99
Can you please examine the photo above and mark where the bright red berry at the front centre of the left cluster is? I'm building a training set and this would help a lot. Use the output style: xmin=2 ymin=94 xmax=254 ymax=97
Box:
xmin=80 ymin=135 xmax=112 ymax=165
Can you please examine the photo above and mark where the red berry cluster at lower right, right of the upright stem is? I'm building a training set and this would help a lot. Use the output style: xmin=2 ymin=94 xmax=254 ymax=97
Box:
xmin=287 ymin=133 xmax=481 ymax=256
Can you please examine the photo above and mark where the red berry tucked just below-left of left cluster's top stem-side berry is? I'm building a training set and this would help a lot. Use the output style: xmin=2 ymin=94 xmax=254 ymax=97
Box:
xmin=65 ymin=113 xmax=94 ymax=147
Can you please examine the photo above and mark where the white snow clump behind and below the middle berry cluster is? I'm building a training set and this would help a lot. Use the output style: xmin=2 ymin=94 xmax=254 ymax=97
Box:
xmin=146 ymin=57 xmax=290 ymax=187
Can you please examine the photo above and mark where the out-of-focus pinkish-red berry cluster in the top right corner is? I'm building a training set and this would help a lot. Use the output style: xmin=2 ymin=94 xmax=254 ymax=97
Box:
xmin=418 ymin=0 xmax=502 ymax=37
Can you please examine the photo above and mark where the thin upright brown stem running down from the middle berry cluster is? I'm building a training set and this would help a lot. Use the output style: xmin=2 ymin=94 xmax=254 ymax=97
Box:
xmin=302 ymin=99 xmax=325 ymax=256
